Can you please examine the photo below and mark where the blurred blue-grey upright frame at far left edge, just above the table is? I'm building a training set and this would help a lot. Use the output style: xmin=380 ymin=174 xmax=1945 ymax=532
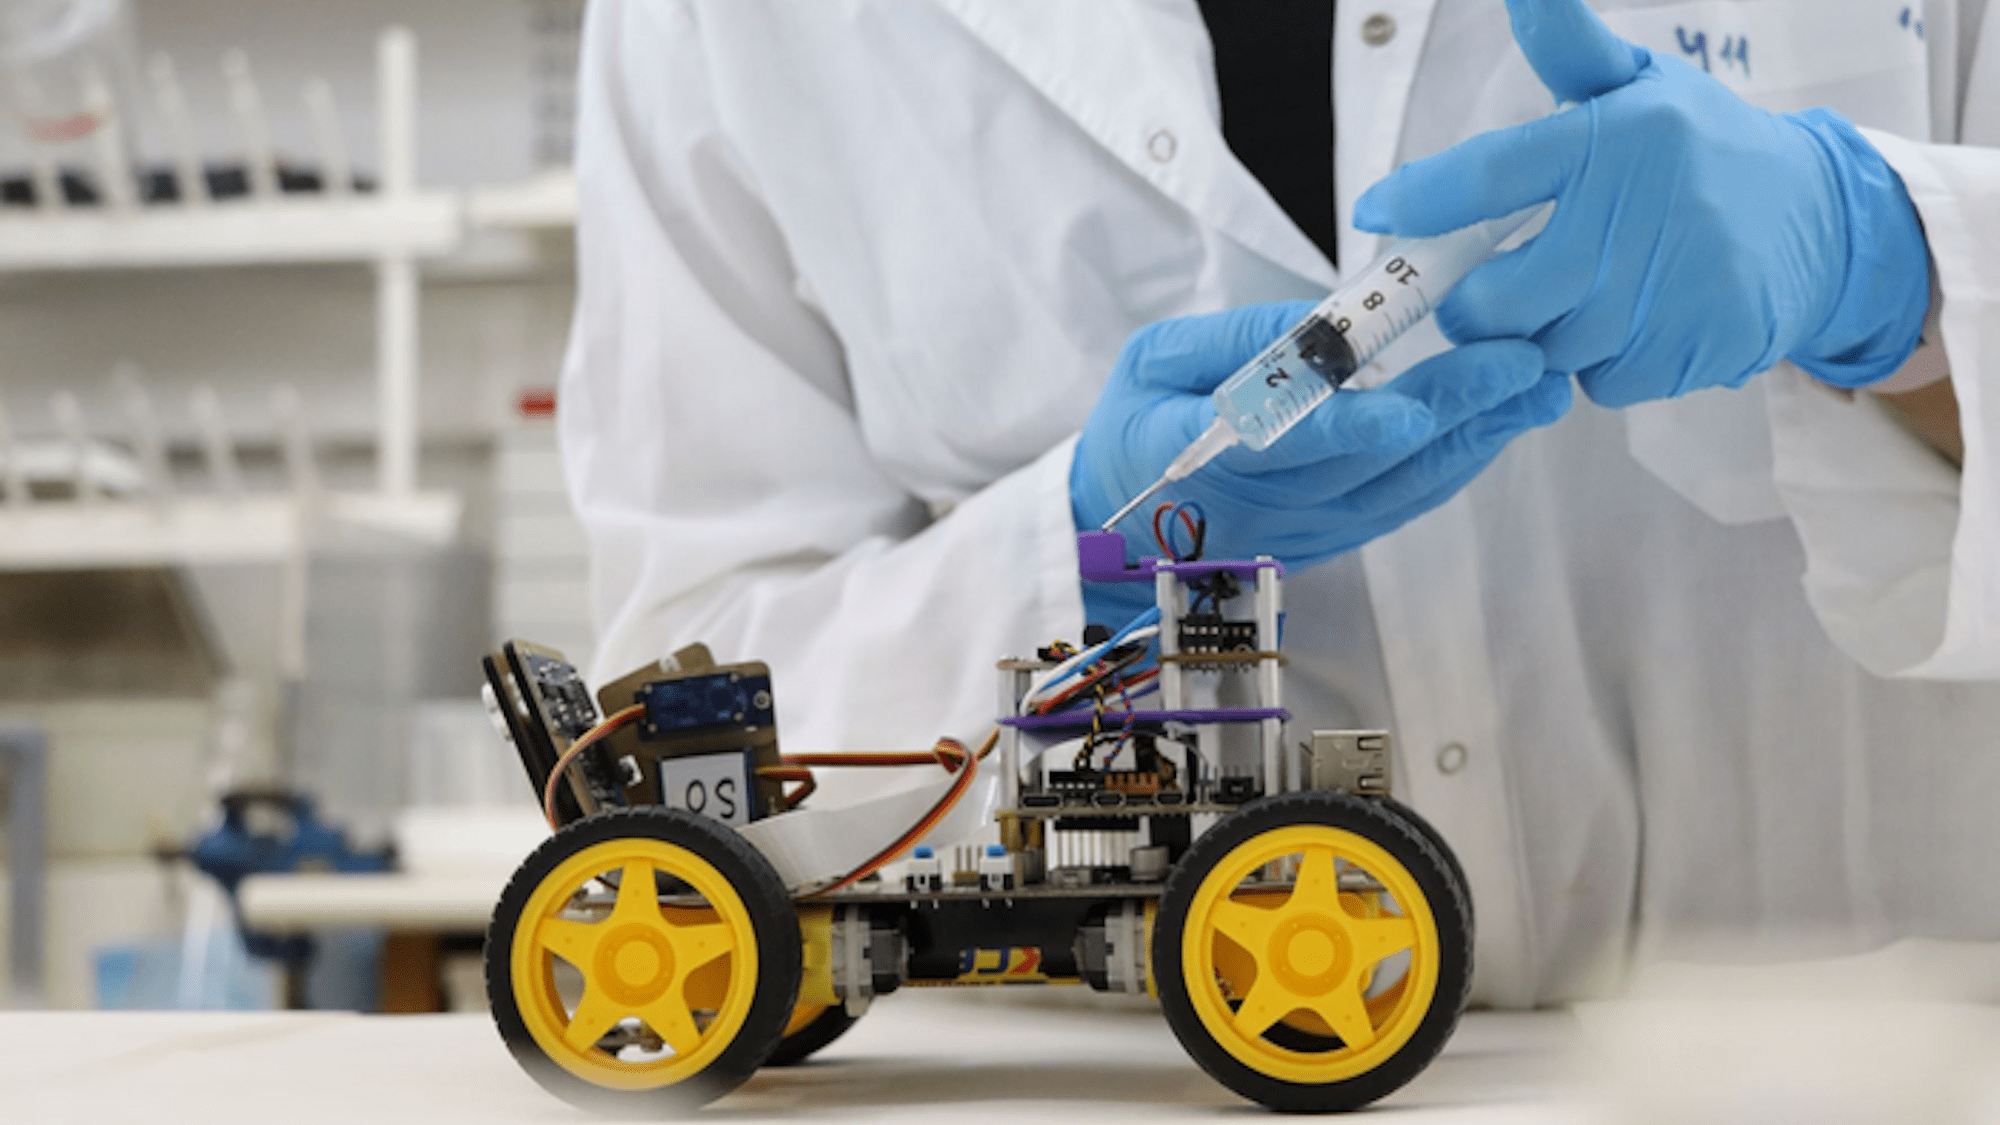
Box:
xmin=0 ymin=723 xmax=48 ymax=1007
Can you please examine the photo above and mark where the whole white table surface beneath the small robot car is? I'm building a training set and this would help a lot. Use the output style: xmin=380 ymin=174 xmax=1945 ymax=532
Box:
xmin=15 ymin=989 xmax=2000 ymax=1125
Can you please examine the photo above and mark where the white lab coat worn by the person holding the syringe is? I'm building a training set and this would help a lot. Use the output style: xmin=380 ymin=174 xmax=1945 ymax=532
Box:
xmin=562 ymin=0 xmax=2000 ymax=1005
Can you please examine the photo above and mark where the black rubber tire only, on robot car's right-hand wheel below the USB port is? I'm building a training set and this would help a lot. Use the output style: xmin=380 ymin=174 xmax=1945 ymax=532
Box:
xmin=1152 ymin=791 xmax=1472 ymax=1113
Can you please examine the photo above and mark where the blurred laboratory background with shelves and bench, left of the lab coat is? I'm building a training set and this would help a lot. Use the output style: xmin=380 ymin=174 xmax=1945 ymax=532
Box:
xmin=0 ymin=0 xmax=590 ymax=1011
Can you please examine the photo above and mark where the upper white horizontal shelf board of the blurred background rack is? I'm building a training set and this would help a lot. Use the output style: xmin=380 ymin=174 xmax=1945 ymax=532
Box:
xmin=0 ymin=192 xmax=464 ymax=272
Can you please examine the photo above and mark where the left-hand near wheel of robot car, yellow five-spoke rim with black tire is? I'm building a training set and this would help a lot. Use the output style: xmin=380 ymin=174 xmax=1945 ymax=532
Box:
xmin=486 ymin=809 xmax=800 ymax=1113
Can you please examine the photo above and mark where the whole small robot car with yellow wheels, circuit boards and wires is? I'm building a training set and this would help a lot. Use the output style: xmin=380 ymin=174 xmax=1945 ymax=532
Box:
xmin=468 ymin=532 xmax=1472 ymax=1115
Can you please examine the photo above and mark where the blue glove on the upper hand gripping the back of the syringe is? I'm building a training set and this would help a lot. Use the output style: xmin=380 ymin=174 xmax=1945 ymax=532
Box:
xmin=1354 ymin=0 xmax=1930 ymax=406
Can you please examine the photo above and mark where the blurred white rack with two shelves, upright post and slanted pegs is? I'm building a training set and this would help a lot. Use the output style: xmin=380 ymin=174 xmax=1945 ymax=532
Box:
xmin=0 ymin=28 xmax=576 ymax=571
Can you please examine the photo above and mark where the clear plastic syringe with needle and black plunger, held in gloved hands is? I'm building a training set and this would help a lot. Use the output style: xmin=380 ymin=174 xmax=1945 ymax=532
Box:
xmin=1104 ymin=204 xmax=1552 ymax=530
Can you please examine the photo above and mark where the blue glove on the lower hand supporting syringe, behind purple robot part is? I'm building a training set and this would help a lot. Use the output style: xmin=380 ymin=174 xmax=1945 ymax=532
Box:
xmin=1070 ymin=300 xmax=1570 ymax=625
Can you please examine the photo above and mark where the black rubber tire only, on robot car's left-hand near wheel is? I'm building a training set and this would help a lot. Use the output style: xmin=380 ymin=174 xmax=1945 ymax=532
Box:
xmin=486 ymin=807 xmax=802 ymax=1117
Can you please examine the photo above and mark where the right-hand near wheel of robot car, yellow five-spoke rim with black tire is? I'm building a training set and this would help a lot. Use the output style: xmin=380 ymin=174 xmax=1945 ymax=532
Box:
xmin=1152 ymin=793 xmax=1472 ymax=1113
